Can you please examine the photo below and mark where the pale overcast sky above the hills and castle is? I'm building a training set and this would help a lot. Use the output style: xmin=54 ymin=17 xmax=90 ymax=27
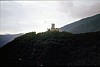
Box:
xmin=0 ymin=0 xmax=100 ymax=34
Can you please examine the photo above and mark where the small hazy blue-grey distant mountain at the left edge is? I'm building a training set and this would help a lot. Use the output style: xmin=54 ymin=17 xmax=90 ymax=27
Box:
xmin=0 ymin=34 xmax=22 ymax=47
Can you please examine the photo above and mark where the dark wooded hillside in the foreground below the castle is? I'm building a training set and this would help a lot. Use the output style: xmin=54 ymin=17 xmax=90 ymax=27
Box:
xmin=0 ymin=32 xmax=100 ymax=66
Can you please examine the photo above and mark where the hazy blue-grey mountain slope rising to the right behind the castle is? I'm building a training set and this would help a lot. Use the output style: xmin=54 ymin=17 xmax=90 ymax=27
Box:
xmin=60 ymin=14 xmax=100 ymax=33
